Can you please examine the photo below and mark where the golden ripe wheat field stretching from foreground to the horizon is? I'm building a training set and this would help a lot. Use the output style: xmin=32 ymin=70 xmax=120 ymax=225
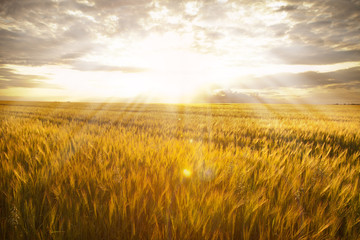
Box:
xmin=0 ymin=102 xmax=360 ymax=239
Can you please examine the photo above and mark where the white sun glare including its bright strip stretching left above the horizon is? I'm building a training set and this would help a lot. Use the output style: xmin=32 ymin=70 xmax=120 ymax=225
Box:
xmin=36 ymin=32 xmax=246 ymax=103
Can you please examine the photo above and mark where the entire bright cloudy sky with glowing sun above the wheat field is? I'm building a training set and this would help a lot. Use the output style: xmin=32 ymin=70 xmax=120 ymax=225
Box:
xmin=0 ymin=0 xmax=360 ymax=104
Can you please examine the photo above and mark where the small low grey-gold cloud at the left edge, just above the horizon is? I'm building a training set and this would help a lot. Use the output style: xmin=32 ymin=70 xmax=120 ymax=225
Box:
xmin=0 ymin=68 xmax=59 ymax=89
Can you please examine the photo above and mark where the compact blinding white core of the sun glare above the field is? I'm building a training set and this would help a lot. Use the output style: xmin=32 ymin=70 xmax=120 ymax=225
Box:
xmin=102 ymin=33 xmax=224 ymax=102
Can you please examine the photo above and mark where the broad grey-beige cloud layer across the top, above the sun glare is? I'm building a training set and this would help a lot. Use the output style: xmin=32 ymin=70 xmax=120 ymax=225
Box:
xmin=0 ymin=0 xmax=360 ymax=65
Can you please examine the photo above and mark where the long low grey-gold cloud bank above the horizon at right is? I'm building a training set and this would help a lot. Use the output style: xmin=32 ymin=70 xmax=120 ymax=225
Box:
xmin=228 ymin=67 xmax=360 ymax=104
